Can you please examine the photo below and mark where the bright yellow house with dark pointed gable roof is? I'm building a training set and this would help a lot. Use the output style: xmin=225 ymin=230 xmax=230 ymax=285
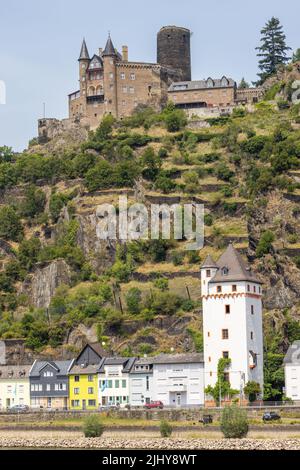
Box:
xmin=68 ymin=343 xmax=103 ymax=410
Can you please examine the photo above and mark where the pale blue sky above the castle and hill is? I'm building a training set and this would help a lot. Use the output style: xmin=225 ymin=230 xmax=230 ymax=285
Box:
xmin=0 ymin=0 xmax=300 ymax=151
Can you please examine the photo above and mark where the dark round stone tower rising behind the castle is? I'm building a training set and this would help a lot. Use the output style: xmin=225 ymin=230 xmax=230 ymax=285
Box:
xmin=157 ymin=26 xmax=191 ymax=81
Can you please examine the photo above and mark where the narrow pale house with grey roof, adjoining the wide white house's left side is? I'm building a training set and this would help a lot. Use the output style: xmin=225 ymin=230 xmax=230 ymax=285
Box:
xmin=130 ymin=357 xmax=153 ymax=406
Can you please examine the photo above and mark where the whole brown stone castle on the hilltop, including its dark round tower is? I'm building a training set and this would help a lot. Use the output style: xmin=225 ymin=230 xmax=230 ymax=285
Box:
xmin=39 ymin=26 xmax=262 ymax=142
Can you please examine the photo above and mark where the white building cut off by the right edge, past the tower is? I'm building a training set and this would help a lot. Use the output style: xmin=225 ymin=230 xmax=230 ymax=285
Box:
xmin=283 ymin=340 xmax=300 ymax=401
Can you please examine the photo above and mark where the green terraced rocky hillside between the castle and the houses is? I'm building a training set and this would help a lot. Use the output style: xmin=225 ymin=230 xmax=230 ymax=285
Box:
xmin=0 ymin=84 xmax=300 ymax=399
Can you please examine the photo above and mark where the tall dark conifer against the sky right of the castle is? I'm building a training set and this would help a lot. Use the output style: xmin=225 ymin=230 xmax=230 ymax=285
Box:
xmin=256 ymin=16 xmax=291 ymax=83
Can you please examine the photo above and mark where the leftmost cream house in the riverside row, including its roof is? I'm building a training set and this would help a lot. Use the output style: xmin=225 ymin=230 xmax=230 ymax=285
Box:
xmin=0 ymin=365 xmax=32 ymax=410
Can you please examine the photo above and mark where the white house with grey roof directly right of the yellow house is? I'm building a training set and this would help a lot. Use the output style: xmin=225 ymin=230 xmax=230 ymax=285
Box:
xmin=98 ymin=357 xmax=135 ymax=407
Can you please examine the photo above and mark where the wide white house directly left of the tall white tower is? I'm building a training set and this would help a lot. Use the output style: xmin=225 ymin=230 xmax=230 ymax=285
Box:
xmin=152 ymin=353 xmax=204 ymax=407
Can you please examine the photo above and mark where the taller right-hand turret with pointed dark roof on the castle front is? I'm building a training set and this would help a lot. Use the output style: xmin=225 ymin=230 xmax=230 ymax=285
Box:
xmin=102 ymin=35 xmax=118 ymax=117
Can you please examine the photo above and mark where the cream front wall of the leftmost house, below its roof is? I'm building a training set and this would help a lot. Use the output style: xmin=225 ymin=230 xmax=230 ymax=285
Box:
xmin=0 ymin=378 xmax=30 ymax=410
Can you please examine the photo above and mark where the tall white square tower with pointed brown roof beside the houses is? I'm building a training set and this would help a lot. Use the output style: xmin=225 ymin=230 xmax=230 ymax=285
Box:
xmin=201 ymin=244 xmax=263 ymax=399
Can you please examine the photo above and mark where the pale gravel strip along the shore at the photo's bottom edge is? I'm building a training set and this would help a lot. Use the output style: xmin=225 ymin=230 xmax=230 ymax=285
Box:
xmin=0 ymin=437 xmax=300 ymax=450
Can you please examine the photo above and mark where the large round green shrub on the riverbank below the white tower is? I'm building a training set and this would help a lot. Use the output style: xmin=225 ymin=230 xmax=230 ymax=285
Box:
xmin=221 ymin=405 xmax=249 ymax=439
